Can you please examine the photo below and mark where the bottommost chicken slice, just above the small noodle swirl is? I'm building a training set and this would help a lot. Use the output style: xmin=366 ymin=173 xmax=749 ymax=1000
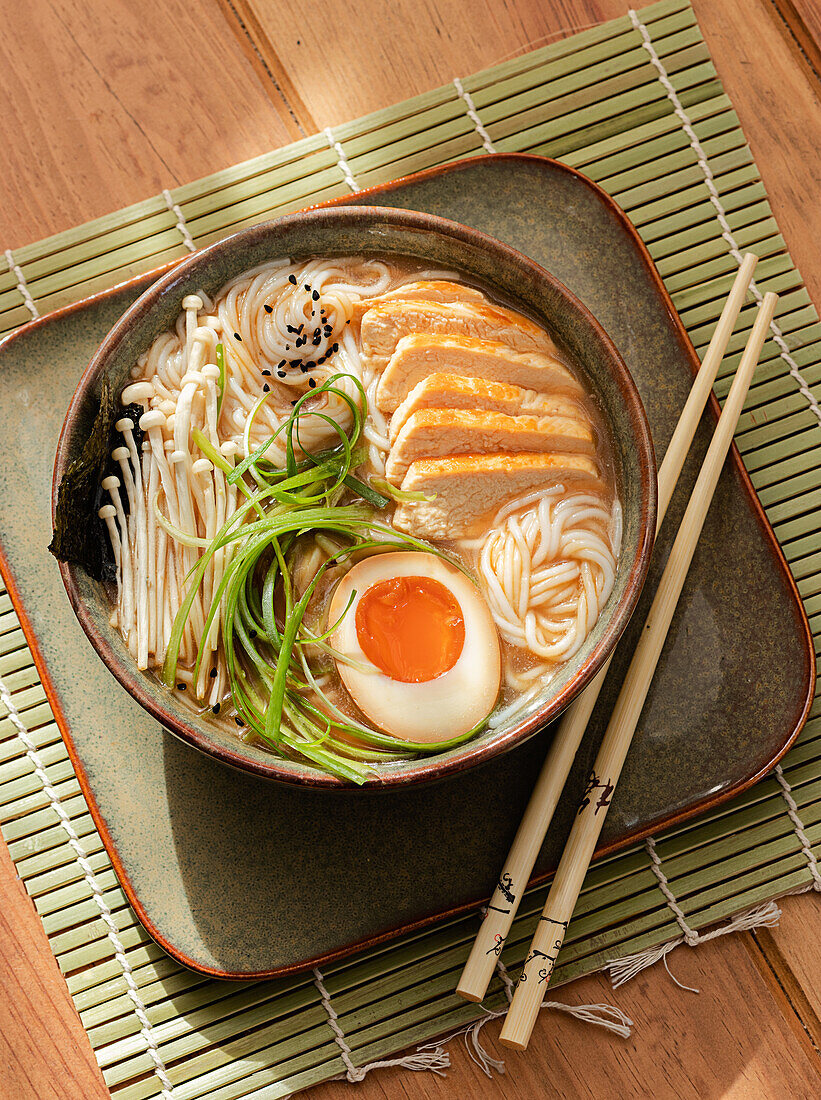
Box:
xmin=393 ymin=454 xmax=602 ymax=539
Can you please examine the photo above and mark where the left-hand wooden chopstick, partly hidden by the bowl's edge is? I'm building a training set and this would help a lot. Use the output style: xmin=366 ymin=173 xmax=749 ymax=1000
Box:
xmin=457 ymin=252 xmax=757 ymax=1001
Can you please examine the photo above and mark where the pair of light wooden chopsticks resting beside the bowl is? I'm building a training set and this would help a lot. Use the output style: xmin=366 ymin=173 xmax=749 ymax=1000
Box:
xmin=457 ymin=254 xmax=778 ymax=1051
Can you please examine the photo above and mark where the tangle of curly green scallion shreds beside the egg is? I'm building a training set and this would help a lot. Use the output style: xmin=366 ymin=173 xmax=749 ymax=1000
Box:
xmin=159 ymin=378 xmax=486 ymax=783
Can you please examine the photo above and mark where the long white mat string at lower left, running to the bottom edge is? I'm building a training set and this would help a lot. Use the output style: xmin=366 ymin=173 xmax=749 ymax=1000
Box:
xmin=0 ymin=660 xmax=174 ymax=1100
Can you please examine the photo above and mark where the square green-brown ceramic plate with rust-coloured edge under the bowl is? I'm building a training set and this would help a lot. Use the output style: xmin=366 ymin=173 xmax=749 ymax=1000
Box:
xmin=0 ymin=155 xmax=813 ymax=978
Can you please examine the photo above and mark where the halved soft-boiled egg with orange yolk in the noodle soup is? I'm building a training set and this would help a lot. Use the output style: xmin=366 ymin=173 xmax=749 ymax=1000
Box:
xmin=328 ymin=551 xmax=501 ymax=743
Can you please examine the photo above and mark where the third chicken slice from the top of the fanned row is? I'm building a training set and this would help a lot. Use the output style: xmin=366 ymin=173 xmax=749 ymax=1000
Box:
xmin=368 ymin=332 xmax=582 ymax=413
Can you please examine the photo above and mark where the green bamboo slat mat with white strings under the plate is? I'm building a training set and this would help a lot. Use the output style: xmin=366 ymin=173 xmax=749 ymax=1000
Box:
xmin=0 ymin=0 xmax=821 ymax=1100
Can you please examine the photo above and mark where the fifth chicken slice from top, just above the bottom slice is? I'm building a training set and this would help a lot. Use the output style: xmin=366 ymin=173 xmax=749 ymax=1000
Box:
xmin=385 ymin=409 xmax=595 ymax=485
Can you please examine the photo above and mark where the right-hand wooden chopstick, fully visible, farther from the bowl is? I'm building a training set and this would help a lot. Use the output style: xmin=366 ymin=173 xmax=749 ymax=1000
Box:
xmin=500 ymin=294 xmax=778 ymax=1051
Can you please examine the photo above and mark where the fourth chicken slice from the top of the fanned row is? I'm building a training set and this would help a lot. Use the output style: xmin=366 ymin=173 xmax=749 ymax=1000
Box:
xmin=391 ymin=374 xmax=585 ymax=440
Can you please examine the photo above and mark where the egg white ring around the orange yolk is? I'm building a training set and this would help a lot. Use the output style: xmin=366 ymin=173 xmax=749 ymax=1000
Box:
xmin=328 ymin=552 xmax=501 ymax=744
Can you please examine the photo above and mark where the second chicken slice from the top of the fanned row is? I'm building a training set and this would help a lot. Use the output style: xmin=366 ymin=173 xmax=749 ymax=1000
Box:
xmin=360 ymin=299 xmax=556 ymax=371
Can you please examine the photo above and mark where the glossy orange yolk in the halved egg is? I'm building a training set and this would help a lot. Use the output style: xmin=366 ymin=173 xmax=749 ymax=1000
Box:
xmin=355 ymin=576 xmax=464 ymax=684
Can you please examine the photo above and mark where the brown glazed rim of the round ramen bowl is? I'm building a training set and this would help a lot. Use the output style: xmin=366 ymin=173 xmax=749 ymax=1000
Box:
xmin=52 ymin=202 xmax=657 ymax=791
